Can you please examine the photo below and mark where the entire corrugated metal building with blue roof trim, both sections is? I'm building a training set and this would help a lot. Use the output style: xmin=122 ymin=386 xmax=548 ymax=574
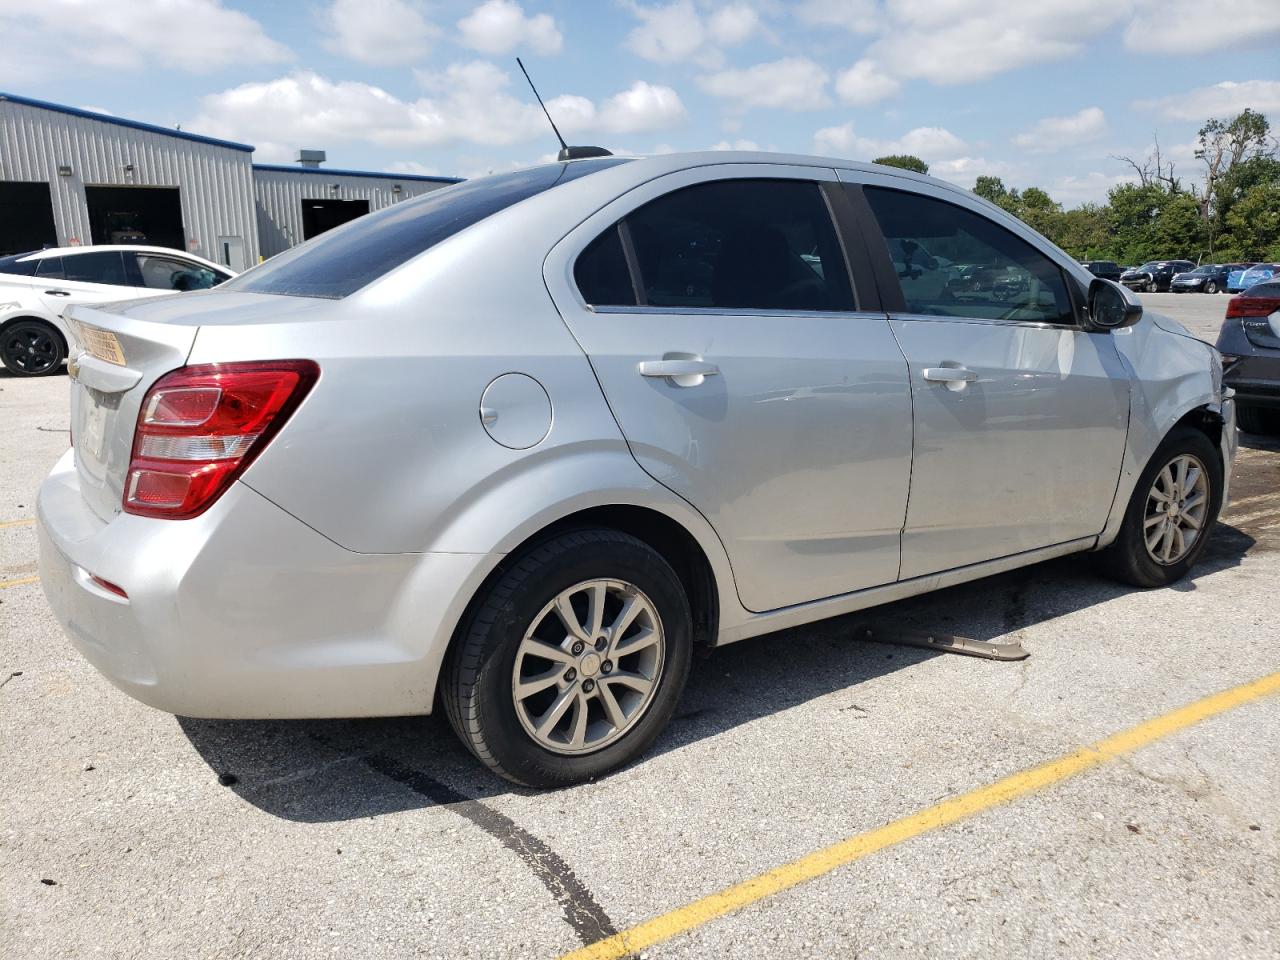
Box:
xmin=0 ymin=93 xmax=457 ymax=270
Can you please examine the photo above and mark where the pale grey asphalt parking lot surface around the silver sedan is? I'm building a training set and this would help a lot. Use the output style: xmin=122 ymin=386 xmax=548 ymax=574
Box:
xmin=0 ymin=294 xmax=1280 ymax=960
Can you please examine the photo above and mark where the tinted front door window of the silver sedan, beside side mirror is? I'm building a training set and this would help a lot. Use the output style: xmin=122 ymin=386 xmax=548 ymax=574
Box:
xmin=864 ymin=187 xmax=1075 ymax=324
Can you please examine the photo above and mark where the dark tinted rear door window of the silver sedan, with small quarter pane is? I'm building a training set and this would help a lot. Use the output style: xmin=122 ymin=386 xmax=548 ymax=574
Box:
xmin=586 ymin=180 xmax=855 ymax=311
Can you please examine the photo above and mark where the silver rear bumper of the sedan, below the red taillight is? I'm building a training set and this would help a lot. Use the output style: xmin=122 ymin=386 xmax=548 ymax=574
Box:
xmin=38 ymin=452 xmax=485 ymax=719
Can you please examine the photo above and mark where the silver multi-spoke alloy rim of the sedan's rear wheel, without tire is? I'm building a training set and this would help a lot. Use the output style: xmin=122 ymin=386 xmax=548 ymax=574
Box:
xmin=511 ymin=580 xmax=667 ymax=754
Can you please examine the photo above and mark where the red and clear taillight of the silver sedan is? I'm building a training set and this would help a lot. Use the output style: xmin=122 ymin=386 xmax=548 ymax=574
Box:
xmin=124 ymin=360 xmax=320 ymax=520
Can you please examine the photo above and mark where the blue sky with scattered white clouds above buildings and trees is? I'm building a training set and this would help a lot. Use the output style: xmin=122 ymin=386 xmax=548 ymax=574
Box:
xmin=0 ymin=0 xmax=1280 ymax=206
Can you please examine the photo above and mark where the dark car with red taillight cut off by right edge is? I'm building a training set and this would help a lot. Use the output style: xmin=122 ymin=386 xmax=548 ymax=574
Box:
xmin=1217 ymin=280 xmax=1280 ymax=434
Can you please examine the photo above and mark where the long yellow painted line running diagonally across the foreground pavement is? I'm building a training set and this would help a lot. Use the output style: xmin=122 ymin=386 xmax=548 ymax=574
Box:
xmin=561 ymin=673 xmax=1280 ymax=960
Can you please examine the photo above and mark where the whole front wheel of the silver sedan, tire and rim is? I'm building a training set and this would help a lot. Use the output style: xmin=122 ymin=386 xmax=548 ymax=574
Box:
xmin=1098 ymin=426 xmax=1222 ymax=588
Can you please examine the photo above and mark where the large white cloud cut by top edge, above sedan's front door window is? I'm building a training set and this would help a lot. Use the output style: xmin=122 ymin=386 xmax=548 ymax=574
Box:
xmin=869 ymin=0 xmax=1126 ymax=84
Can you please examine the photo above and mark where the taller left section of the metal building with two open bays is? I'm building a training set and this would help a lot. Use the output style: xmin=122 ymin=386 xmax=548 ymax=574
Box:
xmin=0 ymin=93 xmax=259 ymax=270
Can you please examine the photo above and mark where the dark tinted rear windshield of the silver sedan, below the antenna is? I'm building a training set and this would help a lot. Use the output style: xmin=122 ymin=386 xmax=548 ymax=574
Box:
xmin=232 ymin=157 xmax=626 ymax=300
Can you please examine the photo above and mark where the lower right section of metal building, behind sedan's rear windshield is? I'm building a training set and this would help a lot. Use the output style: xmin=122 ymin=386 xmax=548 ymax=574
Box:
xmin=253 ymin=165 xmax=457 ymax=257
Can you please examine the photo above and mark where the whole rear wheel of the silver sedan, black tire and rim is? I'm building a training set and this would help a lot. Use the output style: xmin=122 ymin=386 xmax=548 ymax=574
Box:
xmin=442 ymin=529 xmax=692 ymax=787
